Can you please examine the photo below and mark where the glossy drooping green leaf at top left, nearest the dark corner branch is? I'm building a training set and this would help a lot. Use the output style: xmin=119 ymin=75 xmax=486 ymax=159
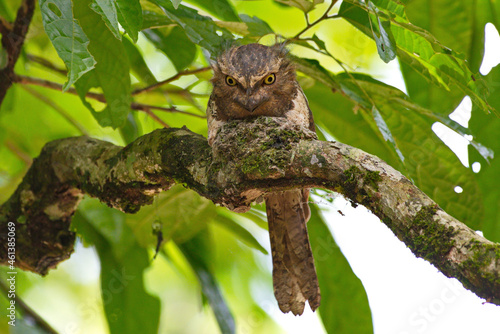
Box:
xmin=40 ymin=0 xmax=96 ymax=91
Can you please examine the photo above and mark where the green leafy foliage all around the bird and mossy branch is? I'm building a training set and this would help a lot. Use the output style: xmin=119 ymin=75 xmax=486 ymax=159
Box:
xmin=0 ymin=0 xmax=500 ymax=333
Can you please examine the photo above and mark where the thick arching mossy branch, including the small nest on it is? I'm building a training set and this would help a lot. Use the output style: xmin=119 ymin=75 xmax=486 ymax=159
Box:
xmin=0 ymin=117 xmax=500 ymax=305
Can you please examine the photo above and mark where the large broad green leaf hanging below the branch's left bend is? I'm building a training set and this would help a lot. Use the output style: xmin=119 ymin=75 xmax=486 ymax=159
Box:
xmin=72 ymin=200 xmax=160 ymax=334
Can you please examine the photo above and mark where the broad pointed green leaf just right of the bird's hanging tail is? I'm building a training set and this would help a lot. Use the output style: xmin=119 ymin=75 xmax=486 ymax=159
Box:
xmin=307 ymin=205 xmax=373 ymax=334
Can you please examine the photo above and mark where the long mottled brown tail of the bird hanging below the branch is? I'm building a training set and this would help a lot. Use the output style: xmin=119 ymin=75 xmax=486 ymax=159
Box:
xmin=265 ymin=189 xmax=321 ymax=315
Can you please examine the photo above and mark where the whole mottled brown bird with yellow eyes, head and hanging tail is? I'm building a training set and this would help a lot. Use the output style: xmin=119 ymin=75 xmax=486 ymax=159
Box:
xmin=207 ymin=44 xmax=320 ymax=315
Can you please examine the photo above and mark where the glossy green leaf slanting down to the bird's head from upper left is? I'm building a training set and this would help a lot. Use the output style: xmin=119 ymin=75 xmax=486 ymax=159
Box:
xmin=153 ymin=0 xmax=233 ymax=58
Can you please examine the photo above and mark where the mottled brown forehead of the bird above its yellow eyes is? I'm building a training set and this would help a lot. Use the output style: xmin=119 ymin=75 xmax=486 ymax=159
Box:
xmin=220 ymin=44 xmax=282 ymax=85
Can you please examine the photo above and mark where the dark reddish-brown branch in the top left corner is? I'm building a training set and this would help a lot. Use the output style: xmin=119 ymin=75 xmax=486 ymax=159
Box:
xmin=0 ymin=0 xmax=35 ymax=105
